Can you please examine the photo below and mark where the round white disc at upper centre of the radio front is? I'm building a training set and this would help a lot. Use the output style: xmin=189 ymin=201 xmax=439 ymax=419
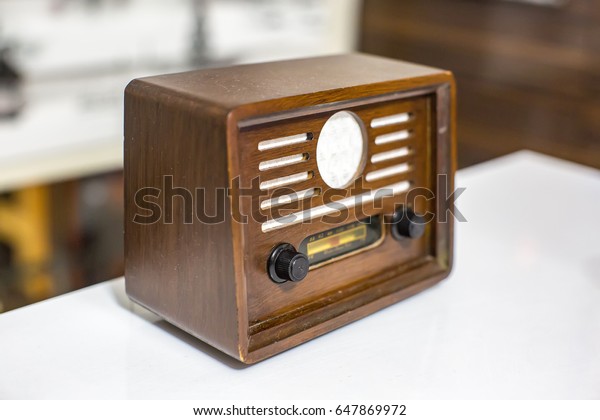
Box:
xmin=317 ymin=111 xmax=367 ymax=188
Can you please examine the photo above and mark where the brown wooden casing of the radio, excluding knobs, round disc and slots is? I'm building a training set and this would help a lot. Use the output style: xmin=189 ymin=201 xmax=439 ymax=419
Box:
xmin=125 ymin=55 xmax=455 ymax=363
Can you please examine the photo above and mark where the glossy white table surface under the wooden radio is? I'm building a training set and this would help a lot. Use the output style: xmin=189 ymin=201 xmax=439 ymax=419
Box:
xmin=0 ymin=152 xmax=600 ymax=400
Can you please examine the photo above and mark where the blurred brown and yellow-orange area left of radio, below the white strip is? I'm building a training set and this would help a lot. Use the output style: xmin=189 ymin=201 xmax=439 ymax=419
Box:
xmin=0 ymin=171 xmax=123 ymax=312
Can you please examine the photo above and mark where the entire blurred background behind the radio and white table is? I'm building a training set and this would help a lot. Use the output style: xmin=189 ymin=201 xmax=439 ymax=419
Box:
xmin=0 ymin=0 xmax=600 ymax=312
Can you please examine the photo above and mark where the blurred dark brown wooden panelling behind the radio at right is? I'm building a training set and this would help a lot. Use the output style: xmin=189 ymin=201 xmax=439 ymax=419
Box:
xmin=360 ymin=0 xmax=600 ymax=167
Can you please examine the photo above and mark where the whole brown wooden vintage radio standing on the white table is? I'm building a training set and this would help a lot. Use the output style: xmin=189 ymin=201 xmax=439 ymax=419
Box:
xmin=125 ymin=55 xmax=455 ymax=363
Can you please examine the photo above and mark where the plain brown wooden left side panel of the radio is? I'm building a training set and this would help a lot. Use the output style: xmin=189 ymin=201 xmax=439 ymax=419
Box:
xmin=124 ymin=80 xmax=240 ymax=358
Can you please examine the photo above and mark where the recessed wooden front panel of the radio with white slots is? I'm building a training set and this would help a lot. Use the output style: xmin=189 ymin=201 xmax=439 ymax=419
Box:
xmin=238 ymin=93 xmax=436 ymax=348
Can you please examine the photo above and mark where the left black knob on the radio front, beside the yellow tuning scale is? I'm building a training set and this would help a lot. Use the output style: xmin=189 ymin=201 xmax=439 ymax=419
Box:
xmin=267 ymin=244 xmax=309 ymax=283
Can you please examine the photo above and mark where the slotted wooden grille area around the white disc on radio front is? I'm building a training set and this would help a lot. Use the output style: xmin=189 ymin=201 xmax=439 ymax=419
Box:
xmin=242 ymin=98 xmax=428 ymax=232
